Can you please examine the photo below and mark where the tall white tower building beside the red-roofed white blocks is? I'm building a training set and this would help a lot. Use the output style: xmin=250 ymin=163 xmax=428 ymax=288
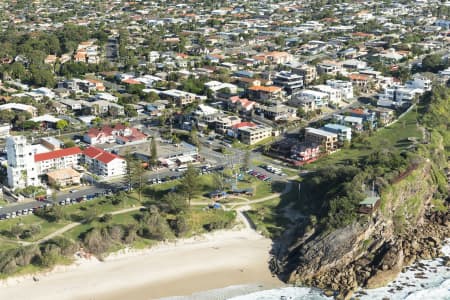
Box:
xmin=6 ymin=136 xmax=39 ymax=189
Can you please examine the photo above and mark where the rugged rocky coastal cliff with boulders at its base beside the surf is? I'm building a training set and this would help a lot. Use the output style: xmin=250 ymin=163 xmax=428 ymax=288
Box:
xmin=272 ymin=159 xmax=450 ymax=298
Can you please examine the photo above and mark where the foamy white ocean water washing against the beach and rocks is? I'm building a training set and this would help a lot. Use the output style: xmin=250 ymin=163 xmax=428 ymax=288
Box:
xmin=228 ymin=240 xmax=450 ymax=300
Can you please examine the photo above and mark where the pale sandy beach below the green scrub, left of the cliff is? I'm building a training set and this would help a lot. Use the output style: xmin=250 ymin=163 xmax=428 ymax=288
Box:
xmin=0 ymin=228 xmax=283 ymax=300
